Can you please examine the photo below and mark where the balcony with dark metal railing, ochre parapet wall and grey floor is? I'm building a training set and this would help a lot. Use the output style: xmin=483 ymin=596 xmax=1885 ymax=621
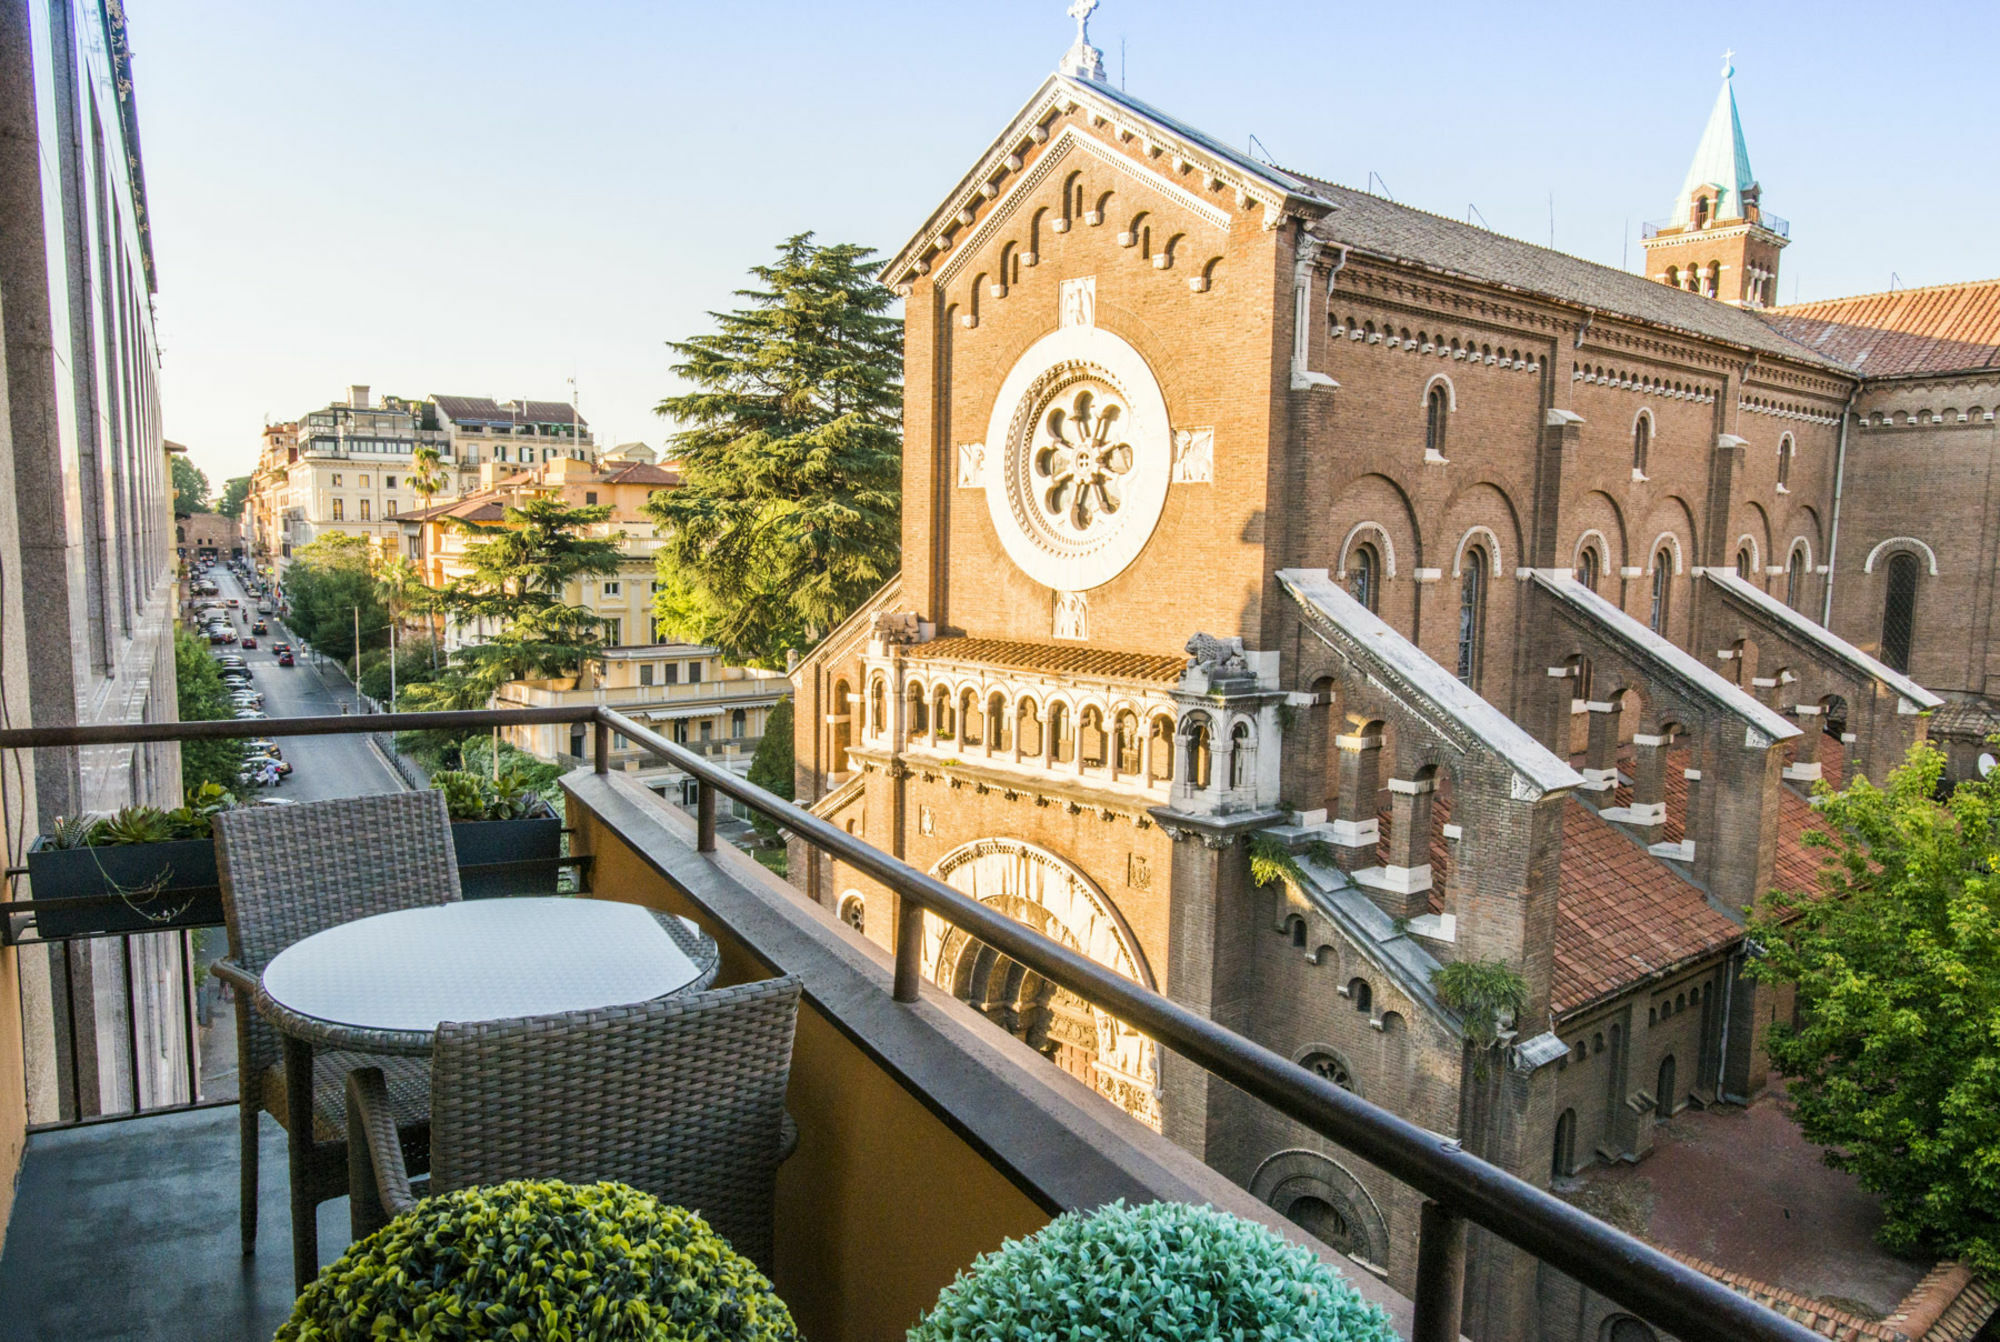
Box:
xmin=0 ymin=706 xmax=1818 ymax=1342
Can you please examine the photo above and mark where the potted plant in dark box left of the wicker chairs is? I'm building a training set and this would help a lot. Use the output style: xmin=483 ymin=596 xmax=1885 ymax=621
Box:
xmin=28 ymin=782 xmax=236 ymax=938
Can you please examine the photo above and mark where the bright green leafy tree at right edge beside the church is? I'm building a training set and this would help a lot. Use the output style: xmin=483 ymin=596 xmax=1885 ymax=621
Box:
xmin=1750 ymin=744 xmax=2000 ymax=1272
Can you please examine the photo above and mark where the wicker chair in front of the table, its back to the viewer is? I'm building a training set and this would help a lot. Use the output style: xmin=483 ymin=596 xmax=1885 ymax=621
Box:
xmin=348 ymin=976 xmax=798 ymax=1272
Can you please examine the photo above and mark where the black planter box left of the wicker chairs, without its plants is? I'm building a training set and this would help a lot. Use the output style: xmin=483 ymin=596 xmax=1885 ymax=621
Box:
xmin=28 ymin=838 xmax=222 ymax=938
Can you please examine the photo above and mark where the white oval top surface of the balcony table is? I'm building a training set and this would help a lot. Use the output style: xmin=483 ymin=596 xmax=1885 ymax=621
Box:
xmin=264 ymin=898 xmax=700 ymax=1030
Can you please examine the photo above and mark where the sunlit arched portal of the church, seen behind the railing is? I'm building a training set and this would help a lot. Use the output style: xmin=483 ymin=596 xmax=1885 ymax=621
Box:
xmin=924 ymin=838 xmax=1160 ymax=1130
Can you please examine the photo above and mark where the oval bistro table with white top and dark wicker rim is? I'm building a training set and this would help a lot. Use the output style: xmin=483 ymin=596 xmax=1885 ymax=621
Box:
xmin=256 ymin=896 xmax=720 ymax=1290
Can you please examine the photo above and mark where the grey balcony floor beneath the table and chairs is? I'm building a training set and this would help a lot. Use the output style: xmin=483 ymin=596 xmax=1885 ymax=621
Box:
xmin=0 ymin=1106 xmax=348 ymax=1342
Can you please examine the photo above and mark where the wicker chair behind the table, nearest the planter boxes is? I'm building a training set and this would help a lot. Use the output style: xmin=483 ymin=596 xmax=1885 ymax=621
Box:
xmin=214 ymin=792 xmax=458 ymax=1290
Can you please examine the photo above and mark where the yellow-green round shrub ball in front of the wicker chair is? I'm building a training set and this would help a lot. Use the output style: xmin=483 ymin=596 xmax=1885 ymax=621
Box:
xmin=276 ymin=1180 xmax=798 ymax=1342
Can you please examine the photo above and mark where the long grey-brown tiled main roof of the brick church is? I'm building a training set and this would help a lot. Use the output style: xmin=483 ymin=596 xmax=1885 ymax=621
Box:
xmin=1306 ymin=178 xmax=1840 ymax=366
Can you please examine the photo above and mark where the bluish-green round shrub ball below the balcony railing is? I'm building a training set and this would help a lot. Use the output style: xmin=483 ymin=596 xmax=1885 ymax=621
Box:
xmin=910 ymin=1202 xmax=1396 ymax=1342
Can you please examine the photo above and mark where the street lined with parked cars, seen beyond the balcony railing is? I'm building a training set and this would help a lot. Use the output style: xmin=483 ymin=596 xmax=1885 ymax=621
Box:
xmin=208 ymin=564 xmax=404 ymax=802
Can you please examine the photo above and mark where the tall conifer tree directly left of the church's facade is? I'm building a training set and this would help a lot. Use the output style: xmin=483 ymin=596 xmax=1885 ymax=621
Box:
xmin=648 ymin=234 xmax=902 ymax=666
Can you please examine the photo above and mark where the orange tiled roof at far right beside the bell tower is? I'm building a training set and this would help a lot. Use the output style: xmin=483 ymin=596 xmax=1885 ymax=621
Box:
xmin=1764 ymin=280 xmax=2000 ymax=378
